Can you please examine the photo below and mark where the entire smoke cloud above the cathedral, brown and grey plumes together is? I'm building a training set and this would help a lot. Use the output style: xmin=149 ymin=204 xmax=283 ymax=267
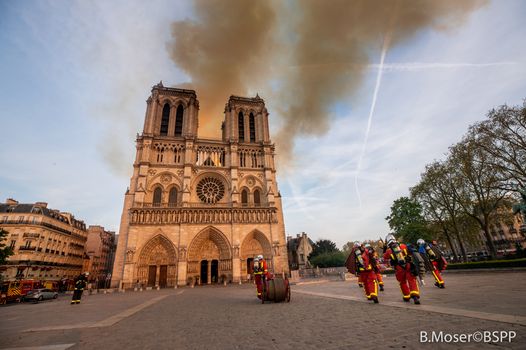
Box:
xmin=168 ymin=0 xmax=487 ymax=165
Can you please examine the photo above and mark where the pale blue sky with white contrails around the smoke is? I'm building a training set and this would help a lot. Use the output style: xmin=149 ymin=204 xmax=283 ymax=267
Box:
xmin=0 ymin=0 xmax=526 ymax=247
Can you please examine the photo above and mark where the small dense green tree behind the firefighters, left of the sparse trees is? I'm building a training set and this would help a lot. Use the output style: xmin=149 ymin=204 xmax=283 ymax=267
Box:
xmin=385 ymin=197 xmax=432 ymax=243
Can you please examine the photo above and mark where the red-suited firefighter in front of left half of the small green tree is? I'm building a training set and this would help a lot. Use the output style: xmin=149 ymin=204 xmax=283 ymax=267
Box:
xmin=384 ymin=234 xmax=420 ymax=305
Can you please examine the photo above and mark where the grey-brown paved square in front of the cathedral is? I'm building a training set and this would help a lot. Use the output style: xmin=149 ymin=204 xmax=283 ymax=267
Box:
xmin=0 ymin=272 xmax=526 ymax=349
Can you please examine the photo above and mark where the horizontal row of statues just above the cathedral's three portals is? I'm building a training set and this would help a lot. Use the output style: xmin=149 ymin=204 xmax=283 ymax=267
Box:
xmin=130 ymin=207 xmax=278 ymax=225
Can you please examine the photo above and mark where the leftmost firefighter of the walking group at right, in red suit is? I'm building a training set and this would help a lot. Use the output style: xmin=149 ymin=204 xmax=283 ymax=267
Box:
xmin=345 ymin=243 xmax=378 ymax=303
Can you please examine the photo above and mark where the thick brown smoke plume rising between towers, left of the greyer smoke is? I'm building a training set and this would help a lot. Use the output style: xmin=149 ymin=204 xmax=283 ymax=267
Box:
xmin=169 ymin=0 xmax=276 ymax=135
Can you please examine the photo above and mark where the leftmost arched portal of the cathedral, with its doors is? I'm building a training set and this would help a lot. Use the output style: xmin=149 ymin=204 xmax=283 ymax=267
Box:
xmin=137 ymin=234 xmax=177 ymax=287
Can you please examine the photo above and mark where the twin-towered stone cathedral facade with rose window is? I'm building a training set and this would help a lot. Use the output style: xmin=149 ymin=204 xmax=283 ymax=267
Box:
xmin=112 ymin=83 xmax=289 ymax=288
